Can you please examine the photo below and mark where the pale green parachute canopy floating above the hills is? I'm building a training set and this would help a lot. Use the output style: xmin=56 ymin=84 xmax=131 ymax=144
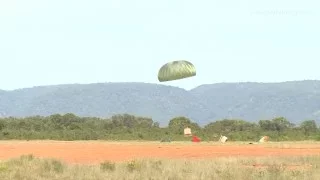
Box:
xmin=158 ymin=60 xmax=196 ymax=82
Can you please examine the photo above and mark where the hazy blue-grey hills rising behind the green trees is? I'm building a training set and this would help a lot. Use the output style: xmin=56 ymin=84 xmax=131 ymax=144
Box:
xmin=0 ymin=81 xmax=320 ymax=125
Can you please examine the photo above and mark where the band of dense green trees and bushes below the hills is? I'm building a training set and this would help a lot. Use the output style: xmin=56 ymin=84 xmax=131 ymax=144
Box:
xmin=0 ymin=113 xmax=320 ymax=141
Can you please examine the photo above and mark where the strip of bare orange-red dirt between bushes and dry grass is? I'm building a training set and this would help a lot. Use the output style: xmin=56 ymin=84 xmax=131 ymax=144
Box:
xmin=0 ymin=141 xmax=320 ymax=164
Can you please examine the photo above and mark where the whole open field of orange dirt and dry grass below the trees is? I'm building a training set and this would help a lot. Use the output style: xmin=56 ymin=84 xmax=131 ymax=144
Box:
xmin=0 ymin=141 xmax=320 ymax=180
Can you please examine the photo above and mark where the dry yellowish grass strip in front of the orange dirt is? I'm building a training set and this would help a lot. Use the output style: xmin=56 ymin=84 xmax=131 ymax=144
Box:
xmin=0 ymin=155 xmax=320 ymax=180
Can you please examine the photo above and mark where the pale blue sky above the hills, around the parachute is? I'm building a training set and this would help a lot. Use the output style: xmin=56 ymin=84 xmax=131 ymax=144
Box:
xmin=0 ymin=0 xmax=320 ymax=90
